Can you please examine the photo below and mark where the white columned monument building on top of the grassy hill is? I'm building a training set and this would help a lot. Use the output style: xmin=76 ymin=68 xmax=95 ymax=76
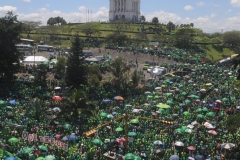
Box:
xmin=109 ymin=0 xmax=140 ymax=21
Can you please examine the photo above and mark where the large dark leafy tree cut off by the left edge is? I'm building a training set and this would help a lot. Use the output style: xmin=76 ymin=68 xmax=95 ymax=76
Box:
xmin=0 ymin=12 xmax=22 ymax=80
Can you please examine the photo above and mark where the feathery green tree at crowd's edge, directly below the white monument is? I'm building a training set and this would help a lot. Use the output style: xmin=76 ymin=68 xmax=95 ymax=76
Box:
xmin=110 ymin=57 xmax=130 ymax=89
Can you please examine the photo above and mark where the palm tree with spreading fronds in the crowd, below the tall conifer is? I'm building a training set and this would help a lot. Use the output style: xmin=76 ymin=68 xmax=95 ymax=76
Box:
xmin=62 ymin=89 xmax=95 ymax=119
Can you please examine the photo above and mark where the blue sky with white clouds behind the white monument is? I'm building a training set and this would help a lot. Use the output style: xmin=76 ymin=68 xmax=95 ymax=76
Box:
xmin=0 ymin=0 xmax=240 ymax=33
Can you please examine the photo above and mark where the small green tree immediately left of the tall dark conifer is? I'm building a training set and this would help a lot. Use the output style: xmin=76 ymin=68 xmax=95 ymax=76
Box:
xmin=53 ymin=57 xmax=67 ymax=79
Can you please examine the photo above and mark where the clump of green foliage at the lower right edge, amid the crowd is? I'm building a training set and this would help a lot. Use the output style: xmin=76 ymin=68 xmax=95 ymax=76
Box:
xmin=225 ymin=113 xmax=240 ymax=131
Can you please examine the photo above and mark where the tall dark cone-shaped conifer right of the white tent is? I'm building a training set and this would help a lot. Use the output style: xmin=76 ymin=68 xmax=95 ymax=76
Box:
xmin=66 ymin=35 xmax=88 ymax=88
